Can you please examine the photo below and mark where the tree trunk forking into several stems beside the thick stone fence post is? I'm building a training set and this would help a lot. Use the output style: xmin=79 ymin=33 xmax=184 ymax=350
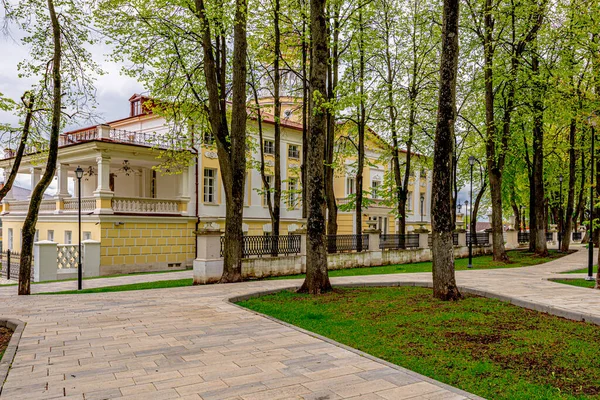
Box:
xmin=195 ymin=0 xmax=246 ymax=283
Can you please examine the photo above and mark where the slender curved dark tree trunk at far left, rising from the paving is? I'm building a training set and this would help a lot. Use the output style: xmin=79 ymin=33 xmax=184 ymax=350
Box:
xmin=19 ymin=0 xmax=63 ymax=295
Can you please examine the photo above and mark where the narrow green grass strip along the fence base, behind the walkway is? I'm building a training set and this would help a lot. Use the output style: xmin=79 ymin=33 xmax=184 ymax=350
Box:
xmin=267 ymin=250 xmax=568 ymax=279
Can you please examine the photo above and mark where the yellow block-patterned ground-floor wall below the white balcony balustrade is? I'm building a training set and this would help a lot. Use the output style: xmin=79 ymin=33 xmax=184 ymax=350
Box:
xmin=100 ymin=221 xmax=196 ymax=266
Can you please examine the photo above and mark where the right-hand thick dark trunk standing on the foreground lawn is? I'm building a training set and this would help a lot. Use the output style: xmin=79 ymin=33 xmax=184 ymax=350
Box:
xmin=431 ymin=0 xmax=461 ymax=300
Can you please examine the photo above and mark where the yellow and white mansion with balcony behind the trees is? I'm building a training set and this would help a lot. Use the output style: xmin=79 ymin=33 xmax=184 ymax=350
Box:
xmin=0 ymin=95 xmax=430 ymax=275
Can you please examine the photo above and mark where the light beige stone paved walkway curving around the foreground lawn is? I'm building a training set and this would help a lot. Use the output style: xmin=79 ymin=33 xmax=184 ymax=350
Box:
xmin=0 ymin=251 xmax=600 ymax=400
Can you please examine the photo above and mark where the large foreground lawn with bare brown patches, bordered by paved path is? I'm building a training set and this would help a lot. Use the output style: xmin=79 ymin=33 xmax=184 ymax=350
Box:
xmin=239 ymin=287 xmax=600 ymax=400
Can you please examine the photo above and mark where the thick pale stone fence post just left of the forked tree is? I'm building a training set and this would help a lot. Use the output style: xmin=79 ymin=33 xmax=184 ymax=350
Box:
xmin=194 ymin=224 xmax=223 ymax=285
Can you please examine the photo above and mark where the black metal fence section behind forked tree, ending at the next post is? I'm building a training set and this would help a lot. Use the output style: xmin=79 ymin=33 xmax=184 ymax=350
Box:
xmin=221 ymin=235 xmax=300 ymax=258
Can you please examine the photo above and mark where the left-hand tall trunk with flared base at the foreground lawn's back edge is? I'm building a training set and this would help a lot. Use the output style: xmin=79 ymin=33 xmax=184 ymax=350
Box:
xmin=299 ymin=0 xmax=331 ymax=294
